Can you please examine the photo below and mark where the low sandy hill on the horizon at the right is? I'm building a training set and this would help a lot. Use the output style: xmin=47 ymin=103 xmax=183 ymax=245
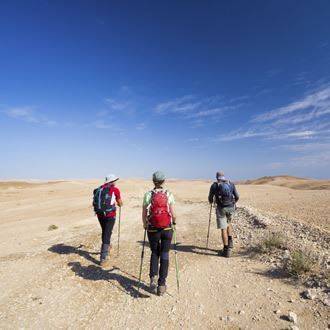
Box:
xmin=240 ymin=175 xmax=330 ymax=190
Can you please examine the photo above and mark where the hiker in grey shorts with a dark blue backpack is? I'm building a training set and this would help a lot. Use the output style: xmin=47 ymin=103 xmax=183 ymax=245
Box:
xmin=209 ymin=172 xmax=239 ymax=258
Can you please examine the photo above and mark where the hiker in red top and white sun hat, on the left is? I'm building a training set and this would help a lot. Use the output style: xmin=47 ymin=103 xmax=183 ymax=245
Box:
xmin=93 ymin=174 xmax=123 ymax=266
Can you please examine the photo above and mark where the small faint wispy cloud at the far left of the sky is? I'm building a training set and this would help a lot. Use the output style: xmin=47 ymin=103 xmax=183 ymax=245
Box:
xmin=1 ymin=106 xmax=57 ymax=126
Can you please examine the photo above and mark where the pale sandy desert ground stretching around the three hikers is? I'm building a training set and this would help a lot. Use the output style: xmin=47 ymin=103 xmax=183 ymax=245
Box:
xmin=0 ymin=180 xmax=330 ymax=329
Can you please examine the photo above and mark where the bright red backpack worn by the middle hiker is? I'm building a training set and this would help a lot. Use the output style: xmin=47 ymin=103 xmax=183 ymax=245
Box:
xmin=149 ymin=190 xmax=171 ymax=228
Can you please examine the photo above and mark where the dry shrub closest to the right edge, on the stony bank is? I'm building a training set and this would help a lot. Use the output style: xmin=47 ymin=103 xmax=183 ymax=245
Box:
xmin=287 ymin=250 xmax=315 ymax=277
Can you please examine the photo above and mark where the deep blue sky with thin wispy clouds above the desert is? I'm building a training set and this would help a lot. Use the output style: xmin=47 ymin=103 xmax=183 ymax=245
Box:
xmin=0 ymin=0 xmax=330 ymax=179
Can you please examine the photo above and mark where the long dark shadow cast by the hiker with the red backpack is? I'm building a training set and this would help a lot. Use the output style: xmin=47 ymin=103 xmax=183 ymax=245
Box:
xmin=68 ymin=262 xmax=150 ymax=298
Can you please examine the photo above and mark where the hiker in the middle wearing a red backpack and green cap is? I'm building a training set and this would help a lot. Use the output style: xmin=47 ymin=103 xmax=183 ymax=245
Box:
xmin=142 ymin=171 xmax=176 ymax=296
